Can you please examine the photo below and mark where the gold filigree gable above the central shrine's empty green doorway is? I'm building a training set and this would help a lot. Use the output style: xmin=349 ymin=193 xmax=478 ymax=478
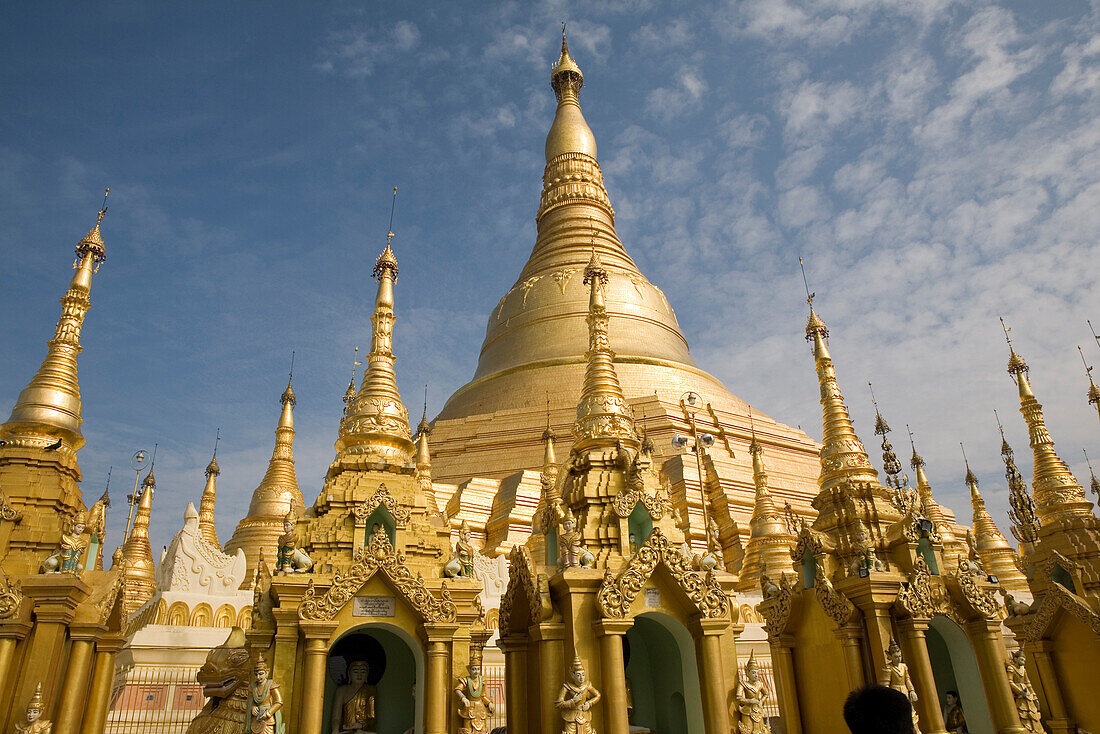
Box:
xmin=596 ymin=528 xmax=729 ymax=618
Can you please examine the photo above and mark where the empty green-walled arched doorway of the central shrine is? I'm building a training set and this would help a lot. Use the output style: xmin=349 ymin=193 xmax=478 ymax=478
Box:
xmin=623 ymin=612 xmax=703 ymax=734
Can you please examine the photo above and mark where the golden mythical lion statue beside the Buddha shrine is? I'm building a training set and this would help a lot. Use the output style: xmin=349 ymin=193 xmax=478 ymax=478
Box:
xmin=187 ymin=627 xmax=252 ymax=734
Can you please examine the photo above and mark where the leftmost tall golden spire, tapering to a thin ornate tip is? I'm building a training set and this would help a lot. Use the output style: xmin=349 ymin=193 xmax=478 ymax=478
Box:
xmin=0 ymin=188 xmax=111 ymax=451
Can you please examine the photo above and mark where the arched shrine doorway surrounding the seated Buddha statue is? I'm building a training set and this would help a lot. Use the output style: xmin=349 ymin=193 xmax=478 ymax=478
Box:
xmin=321 ymin=623 xmax=424 ymax=734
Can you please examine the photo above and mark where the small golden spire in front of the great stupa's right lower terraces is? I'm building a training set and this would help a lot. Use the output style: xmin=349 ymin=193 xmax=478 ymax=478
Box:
xmin=737 ymin=408 xmax=795 ymax=591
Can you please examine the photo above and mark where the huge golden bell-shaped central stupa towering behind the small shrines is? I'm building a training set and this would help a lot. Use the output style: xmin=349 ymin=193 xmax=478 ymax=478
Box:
xmin=431 ymin=31 xmax=817 ymax=589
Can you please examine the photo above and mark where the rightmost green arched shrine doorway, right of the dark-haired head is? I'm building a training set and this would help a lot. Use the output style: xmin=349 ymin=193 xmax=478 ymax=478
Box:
xmin=925 ymin=615 xmax=997 ymax=734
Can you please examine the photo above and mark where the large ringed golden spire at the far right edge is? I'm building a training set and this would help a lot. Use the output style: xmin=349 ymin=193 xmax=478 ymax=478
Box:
xmin=1001 ymin=318 xmax=1092 ymax=526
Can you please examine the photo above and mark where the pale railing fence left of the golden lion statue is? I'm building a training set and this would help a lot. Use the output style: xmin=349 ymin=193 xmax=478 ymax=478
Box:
xmin=105 ymin=667 xmax=206 ymax=734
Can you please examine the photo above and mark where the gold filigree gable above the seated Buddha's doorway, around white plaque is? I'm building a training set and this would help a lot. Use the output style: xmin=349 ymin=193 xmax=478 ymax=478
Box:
xmin=298 ymin=533 xmax=459 ymax=622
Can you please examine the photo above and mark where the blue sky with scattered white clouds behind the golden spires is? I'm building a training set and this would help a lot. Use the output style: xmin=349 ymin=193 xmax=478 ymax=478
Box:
xmin=0 ymin=0 xmax=1100 ymax=556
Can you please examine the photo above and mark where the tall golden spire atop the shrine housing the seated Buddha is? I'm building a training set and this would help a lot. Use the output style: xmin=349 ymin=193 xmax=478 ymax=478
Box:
xmin=336 ymin=186 xmax=414 ymax=465
